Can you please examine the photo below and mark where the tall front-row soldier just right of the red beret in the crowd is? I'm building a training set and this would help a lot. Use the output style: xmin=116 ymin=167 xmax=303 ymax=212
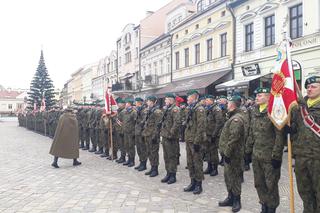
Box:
xmin=184 ymin=90 xmax=207 ymax=194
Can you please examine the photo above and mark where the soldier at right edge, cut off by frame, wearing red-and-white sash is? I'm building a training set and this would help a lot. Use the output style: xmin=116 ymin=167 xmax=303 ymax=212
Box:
xmin=286 ymin=76 xmax=320 ymax=213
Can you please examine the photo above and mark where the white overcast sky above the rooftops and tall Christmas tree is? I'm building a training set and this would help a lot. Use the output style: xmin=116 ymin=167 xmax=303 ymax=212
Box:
xmin=0 ymin=0 xmax=170 ymax=89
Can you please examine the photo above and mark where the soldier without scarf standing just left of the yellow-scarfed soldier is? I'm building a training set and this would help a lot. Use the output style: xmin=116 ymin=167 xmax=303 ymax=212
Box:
xmin=219 ymin=96 xmax=246 ymax=212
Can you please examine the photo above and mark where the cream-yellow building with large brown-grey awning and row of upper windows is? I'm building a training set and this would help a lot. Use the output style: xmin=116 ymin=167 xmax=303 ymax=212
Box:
xmin=158 ymin=0 xmax=234 ymax=95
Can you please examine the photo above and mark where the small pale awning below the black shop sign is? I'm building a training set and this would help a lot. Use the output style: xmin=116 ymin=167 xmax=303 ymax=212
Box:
xmin=215 ymin=75 xmax=262 ymax=91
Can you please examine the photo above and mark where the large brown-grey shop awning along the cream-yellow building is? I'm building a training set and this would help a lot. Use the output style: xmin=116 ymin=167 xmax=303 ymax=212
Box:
xmin=156 ymin=70 xmax=230 ymax=95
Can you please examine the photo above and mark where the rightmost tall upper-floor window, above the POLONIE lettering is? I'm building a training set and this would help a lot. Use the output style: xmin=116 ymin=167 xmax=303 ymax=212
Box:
xmin=290 ymin=4 xmax=303 ymax=39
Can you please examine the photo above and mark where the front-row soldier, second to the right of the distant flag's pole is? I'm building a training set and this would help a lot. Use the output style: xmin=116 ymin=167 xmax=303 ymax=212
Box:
xmin=123 ymin=98 xmax=137 ymax=167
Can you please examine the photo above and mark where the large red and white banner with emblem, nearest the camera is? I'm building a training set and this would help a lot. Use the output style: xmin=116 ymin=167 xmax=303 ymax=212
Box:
xmin=268 ymin=40 xmax=297 ymax=130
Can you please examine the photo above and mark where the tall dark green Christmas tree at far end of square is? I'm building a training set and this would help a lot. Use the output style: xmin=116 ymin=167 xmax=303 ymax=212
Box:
xmin=28 ymin=50 xmax=56 ymax=110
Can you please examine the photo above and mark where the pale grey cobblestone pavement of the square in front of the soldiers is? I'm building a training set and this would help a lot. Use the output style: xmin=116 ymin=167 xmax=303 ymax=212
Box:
xmin=0 ymin=118 xmax=302 ymax=213
